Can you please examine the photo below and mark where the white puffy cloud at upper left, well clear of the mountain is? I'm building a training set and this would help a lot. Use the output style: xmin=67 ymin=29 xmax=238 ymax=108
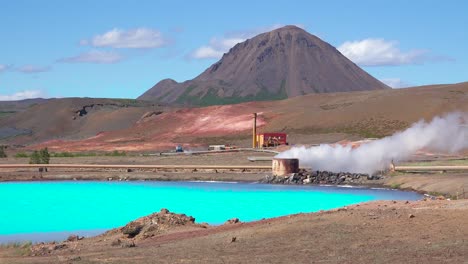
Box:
xmin=80 ymin=28 xmax=167 ymax=49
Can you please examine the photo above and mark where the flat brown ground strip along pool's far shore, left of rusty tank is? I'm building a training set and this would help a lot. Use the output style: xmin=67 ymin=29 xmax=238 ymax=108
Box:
xmin=0 ymin=152 xmax=274 ymax=182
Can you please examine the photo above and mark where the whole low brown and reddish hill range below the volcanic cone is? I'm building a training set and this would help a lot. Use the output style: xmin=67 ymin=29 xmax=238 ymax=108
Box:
xmin=14 ymin=82 xmax=468 ymax=151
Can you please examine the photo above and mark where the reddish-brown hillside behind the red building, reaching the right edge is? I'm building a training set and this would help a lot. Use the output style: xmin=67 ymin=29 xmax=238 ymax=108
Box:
xmin=22 ymin=83 xmax=468 ymax=151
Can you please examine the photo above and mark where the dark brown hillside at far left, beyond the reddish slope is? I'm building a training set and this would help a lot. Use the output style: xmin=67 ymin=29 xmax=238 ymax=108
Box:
xmin=0 ymin=98 xmax=168 ymax=144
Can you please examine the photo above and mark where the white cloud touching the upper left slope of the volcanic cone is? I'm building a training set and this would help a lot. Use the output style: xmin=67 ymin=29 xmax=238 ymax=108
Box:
xmin=189 ymin=24 xmax=304 ymax=59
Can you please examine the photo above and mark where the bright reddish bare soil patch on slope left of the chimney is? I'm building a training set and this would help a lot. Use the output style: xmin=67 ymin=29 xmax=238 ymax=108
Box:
xmin=35 ymin=105 xmax=265 ymax=151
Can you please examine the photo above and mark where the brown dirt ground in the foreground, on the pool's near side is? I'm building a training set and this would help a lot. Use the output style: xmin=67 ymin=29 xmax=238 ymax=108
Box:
xmin=0 ymin=200 xmax=468 ymax=263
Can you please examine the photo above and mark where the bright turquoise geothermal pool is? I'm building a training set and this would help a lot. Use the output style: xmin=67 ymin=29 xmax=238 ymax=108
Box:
xmin=0 ymin=181 xmax=421 ymax=243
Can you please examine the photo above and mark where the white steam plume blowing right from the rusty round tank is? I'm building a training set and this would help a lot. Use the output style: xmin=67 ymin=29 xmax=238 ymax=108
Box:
xmin=276 ymin=113 xmax=468 ymax=174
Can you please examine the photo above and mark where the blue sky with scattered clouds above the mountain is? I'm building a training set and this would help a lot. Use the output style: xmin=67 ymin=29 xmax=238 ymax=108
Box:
xmin=0 ymin=0 xmax=468 ymax=100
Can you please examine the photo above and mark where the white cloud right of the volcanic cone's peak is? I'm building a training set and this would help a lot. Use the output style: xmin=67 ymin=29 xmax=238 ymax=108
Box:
xmin=338 ymin=38 xmax=429 ymax=66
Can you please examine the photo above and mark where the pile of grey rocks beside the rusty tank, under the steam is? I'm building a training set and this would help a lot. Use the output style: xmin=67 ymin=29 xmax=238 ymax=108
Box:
xmin=260 ymin=170 xmax=383 ymax=185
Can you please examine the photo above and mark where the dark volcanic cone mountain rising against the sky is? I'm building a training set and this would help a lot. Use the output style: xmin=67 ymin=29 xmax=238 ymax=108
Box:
xmin=138 ymin=26 xmax=388 ymax=105
